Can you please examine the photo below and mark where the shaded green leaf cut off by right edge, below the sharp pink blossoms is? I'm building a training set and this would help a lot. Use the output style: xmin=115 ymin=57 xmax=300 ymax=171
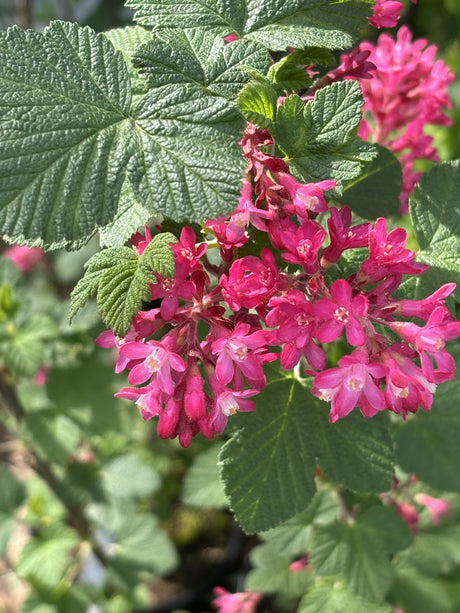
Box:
xmin=396 ymin=370 xmax=460 ymax=492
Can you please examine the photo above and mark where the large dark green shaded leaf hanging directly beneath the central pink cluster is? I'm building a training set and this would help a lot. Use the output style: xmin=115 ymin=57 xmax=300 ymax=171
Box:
xmin=220 ymin=366 xmax=394 ymax=532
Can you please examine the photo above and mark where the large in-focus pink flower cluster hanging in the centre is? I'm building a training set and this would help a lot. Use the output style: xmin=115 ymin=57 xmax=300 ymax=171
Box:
xmin=97 ymin=117 xmax=460 ymax=446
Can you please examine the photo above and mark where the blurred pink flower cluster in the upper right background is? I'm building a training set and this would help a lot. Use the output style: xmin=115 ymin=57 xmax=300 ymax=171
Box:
xmin=348 ymin=26 xmax=454 ymax=213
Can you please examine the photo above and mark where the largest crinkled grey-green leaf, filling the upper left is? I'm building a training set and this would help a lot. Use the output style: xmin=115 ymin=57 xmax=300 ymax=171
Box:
xmin=0 ymin=22 xmax=250 ymax=248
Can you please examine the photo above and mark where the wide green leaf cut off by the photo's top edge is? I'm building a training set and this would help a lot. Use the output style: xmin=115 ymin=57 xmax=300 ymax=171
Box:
xmin=127 ymin=0 xmax=371 ymax=50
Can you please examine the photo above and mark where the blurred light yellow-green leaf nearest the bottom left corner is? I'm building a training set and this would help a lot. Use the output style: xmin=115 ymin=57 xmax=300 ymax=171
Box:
xmin=16 ymin=525 xmax=79 ymax=588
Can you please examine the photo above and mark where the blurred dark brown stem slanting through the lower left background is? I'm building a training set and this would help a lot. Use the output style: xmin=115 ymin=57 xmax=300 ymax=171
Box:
xmin=0 ymin=374 xmax=107 ymax=565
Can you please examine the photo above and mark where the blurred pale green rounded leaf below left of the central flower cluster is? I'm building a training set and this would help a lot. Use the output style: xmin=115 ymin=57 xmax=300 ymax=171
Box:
xmin=102 ymin=455 xmax=160 ymax=498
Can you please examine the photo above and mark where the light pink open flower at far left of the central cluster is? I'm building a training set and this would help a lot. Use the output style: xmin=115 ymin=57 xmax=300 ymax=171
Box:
xmin=120 ymin=341 xmax=185 ymax=394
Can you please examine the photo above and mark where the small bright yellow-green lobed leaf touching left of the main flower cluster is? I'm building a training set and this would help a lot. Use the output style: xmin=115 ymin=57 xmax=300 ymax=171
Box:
xmin=69 ymin=232 xmax=177 ymax=336
